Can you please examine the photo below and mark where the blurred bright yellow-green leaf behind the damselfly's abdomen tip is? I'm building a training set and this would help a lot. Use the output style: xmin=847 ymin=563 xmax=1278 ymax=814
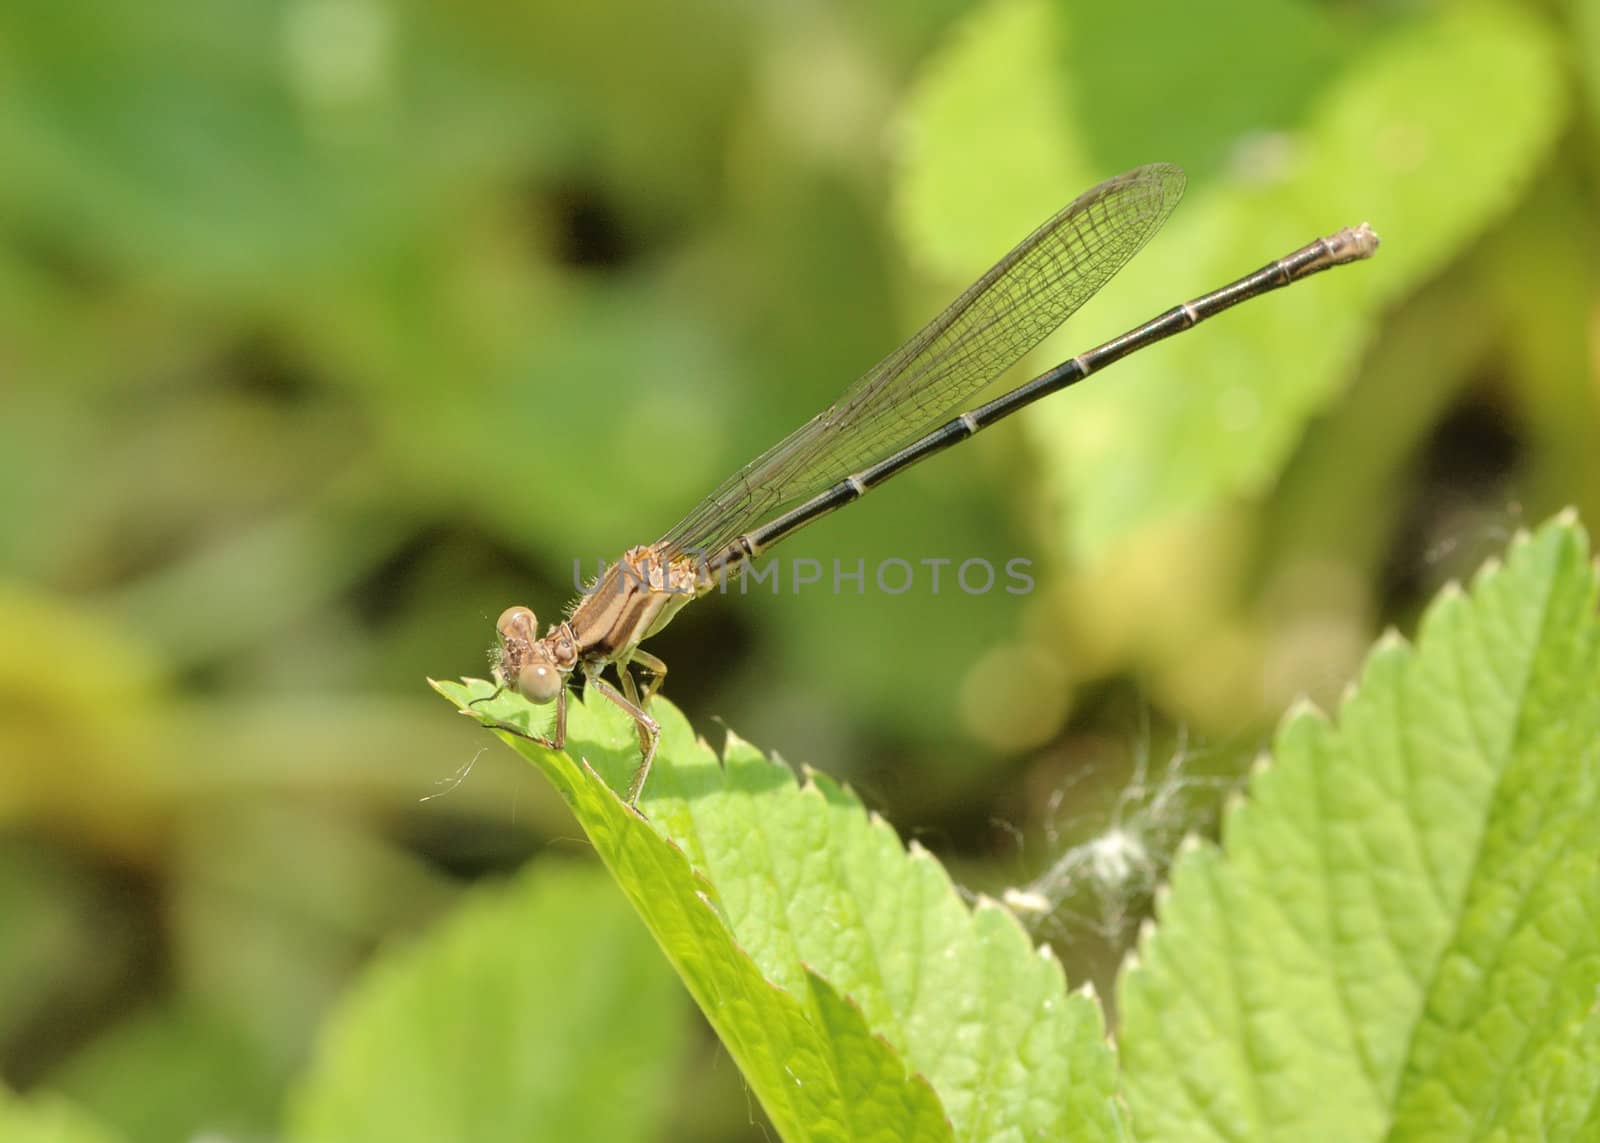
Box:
xmin=899 ymin=0 xmax=1565 ymax=552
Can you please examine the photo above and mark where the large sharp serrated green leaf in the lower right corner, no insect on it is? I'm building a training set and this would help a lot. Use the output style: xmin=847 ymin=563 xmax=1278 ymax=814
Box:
xmin=1120 ymin=519 xmax=1600 ymax=1141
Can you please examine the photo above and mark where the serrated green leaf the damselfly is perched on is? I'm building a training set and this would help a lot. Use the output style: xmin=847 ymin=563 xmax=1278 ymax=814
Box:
xmin=437 ymin=682 xmax=1118 ymax=1140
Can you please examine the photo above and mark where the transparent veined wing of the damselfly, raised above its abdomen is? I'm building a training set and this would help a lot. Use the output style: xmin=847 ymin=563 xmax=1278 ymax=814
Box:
xmin=658 ymin=163 xmax=1184 ymax=555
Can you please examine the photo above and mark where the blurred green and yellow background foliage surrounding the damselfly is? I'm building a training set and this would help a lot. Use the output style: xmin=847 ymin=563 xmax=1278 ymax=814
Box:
xmin=0 ymin=0 xmax=1600 ymax=1140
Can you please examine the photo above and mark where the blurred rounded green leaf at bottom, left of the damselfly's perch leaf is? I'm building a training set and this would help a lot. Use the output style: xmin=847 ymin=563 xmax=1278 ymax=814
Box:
xmin=291 ymin=863 xmax=686 ymax=1143
